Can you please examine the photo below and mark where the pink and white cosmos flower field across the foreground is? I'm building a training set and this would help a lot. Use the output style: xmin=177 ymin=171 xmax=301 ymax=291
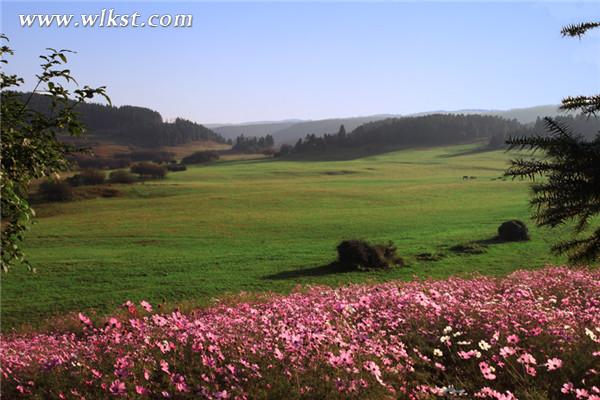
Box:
xmin=0 ymin=267 xmax=600 ymax=400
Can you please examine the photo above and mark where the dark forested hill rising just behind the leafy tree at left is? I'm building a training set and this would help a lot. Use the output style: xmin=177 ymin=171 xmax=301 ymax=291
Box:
xmin=11 ymin=93 xmax=226 ymax=147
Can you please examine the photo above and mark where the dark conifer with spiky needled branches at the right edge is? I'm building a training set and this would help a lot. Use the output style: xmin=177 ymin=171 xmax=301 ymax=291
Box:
xmin=506 ymin=22 xmax=600 ymax=263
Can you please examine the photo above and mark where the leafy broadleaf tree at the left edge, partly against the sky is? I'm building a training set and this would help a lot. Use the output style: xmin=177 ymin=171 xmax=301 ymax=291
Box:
xmin=0 ymin=35 xmax=110 ymax=271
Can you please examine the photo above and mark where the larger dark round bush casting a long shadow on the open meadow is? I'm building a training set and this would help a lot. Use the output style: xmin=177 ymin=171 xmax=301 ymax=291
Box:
xmin=337 ymin=240 xmax=404 ymax=270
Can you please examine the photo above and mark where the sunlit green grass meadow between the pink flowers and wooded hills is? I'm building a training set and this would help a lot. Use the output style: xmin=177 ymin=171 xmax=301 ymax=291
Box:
xmin=1 ymin=146 xmax=564 ymax=331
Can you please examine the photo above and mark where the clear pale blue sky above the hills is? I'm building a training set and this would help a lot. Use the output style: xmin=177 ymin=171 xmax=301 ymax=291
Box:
xmin=1 ymin=0 xmax=600 ymax=123
